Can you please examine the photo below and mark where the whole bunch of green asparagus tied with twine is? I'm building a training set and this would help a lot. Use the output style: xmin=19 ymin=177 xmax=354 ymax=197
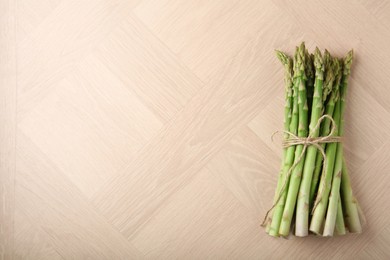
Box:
xmin=263 ymin=43 xmax=362 ymax=236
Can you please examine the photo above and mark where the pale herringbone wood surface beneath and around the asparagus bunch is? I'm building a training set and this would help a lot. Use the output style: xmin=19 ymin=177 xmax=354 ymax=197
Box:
xmin=0 ymin=0 xmax=390 ymax=259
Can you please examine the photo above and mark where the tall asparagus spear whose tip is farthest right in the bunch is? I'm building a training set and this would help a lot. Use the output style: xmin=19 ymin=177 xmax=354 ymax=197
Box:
xmin=324 ymin=51 xmax=353 ymax=236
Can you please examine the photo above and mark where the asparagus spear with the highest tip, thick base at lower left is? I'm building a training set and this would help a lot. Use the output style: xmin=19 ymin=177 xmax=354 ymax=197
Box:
xmin=279 ymin=43 xmax=309 ymax=236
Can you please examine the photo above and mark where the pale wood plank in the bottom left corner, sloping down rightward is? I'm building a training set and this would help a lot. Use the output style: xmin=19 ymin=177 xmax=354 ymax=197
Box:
xmin=16 ymin=133 xmax=142 ymax=259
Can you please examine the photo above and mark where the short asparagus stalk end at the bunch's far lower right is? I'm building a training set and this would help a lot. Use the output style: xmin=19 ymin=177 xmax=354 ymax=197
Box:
xmin=341 ymin=160 xmax=362 ymax=233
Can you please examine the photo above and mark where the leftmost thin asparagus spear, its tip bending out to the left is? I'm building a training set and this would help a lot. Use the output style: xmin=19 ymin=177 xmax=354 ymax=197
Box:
xmin=266 ymin=51 xmax=293 ymax=233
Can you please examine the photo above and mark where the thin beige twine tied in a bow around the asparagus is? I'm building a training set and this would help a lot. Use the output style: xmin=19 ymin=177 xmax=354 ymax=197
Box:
xmin=261 ymin=115 xmax=342 ymax=227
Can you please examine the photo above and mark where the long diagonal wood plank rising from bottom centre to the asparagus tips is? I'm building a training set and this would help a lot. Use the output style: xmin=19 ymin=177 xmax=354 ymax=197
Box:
xmin=94 ymin=11 xmax=291 ymax=240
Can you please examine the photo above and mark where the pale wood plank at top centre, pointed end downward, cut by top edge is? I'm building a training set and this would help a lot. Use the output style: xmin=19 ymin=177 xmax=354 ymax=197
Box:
xmin=134 ymin=0 xmax=299 ymax=83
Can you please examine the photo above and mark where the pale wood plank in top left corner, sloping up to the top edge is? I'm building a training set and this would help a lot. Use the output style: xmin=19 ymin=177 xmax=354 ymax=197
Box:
xmin=18 ymin=0 xmax=140 ymax=118
